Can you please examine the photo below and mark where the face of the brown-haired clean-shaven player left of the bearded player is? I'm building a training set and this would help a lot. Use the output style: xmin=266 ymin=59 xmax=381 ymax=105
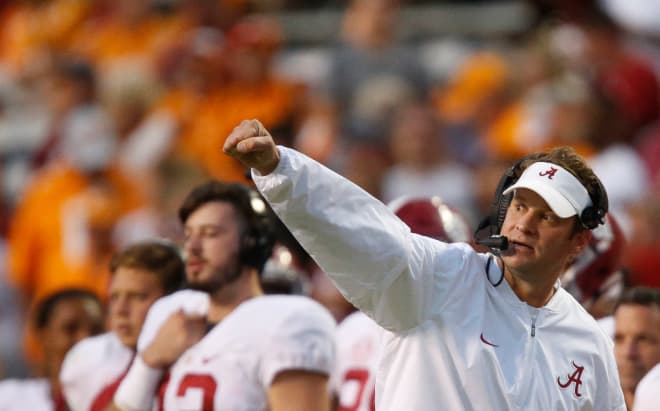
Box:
xmin=108 ymin=267 xmax=163 ymax=348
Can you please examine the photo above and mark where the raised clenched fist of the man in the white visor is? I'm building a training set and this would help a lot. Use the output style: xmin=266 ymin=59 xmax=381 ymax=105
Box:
xmin=223 ymin=120 xmax=280 ymax=175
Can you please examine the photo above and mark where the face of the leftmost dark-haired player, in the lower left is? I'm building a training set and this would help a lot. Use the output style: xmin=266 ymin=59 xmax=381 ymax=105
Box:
xmin=39 ymin=298 xmax=103 ymax=369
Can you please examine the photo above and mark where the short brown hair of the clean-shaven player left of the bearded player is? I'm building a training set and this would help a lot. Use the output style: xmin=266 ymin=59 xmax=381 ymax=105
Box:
xmin=110 ymin=241 xmax=186 ymax=294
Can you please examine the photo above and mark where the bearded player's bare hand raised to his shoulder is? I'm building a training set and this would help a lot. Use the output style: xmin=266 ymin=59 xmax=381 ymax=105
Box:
xmin=142 ymin=310 xmax=206 ymax=368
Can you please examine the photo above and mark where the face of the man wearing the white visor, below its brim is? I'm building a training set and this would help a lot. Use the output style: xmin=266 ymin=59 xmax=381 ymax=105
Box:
xmin=502 ymin=188 xmax=589 ymax=281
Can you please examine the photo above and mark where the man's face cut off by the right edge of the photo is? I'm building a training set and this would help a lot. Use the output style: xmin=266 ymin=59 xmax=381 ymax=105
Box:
xmin=614 ymin=304 xmax=660 ymax=391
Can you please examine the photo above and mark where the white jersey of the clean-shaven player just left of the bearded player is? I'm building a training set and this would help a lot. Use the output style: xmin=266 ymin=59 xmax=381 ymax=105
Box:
xmin=60 ymin=333 xmax=134 ymax=411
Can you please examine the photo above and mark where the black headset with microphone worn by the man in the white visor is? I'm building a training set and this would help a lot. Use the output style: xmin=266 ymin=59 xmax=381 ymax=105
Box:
xmin=474 ymin=153 xmax=609 ymax=252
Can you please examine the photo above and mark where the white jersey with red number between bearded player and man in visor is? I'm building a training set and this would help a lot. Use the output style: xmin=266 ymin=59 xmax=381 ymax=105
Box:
xmin=331 ymin=311 xmax=383 ymax=411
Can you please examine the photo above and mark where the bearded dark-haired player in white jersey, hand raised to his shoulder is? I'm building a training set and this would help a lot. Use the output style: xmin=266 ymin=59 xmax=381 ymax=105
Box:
xmin=114 ymin=181 xmax=335 ymax=411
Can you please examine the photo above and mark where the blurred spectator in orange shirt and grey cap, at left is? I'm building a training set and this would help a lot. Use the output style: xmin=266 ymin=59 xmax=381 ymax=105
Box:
xmin=8 ymin=134 xmax=143 ymax=303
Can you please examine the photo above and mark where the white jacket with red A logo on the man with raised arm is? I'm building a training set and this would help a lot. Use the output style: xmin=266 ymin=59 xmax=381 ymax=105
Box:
xmin=253 ymin=147 xmax=625 ymax=411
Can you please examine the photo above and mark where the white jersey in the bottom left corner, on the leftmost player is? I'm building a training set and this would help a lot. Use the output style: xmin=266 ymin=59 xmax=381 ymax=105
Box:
xmin=0 ymin=378 xmax=56 ymax=411
